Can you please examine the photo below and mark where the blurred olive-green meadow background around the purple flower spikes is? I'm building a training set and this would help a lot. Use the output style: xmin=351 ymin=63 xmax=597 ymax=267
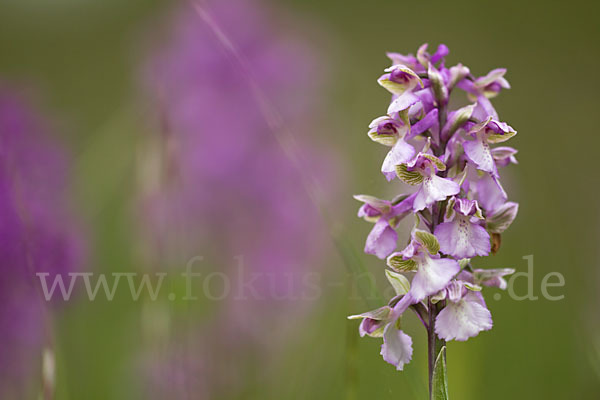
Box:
xmin=0 ymin=0 xmax=600 ymax=400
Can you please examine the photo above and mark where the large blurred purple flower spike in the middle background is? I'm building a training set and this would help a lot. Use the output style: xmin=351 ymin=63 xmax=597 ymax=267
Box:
xmin=140 ymin=0 xmax=340 ymax=397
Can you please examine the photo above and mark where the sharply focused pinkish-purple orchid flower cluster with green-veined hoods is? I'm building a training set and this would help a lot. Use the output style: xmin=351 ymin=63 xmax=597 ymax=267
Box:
xmin=349 ymin=44 xmax=518 ymax=370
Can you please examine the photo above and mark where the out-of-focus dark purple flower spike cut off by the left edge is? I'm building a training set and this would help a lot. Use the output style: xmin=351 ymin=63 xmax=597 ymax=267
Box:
xmin=0 ymin=89 xmax=82 ymax=398
